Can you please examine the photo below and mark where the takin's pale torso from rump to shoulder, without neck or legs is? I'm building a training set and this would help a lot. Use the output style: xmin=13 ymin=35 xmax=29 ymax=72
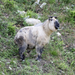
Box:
xmin=15 ymin=23 xmax=48 ymax=46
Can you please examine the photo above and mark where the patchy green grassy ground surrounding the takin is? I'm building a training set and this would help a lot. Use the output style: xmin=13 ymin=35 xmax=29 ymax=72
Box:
xmin=0 ymin=0 xmax=75 ymax=75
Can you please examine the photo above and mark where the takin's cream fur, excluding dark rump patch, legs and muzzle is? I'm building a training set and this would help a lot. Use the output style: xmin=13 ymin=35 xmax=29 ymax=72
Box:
xmin=14 ymin=18 xmax=56 ymax=46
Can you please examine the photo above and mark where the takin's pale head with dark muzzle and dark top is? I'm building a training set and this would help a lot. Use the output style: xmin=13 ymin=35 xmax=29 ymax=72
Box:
xmin=49 ymin=17 xmax=59 ymax=31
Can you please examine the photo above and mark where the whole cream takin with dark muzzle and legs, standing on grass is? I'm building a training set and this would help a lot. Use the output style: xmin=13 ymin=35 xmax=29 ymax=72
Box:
xmin=14 ymin=17 xmax=59 ymax=60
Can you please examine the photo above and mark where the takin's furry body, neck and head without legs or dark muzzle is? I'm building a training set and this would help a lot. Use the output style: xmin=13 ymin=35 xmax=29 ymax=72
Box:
xmin=14 ymin=17 xmax=57 ymax=60
